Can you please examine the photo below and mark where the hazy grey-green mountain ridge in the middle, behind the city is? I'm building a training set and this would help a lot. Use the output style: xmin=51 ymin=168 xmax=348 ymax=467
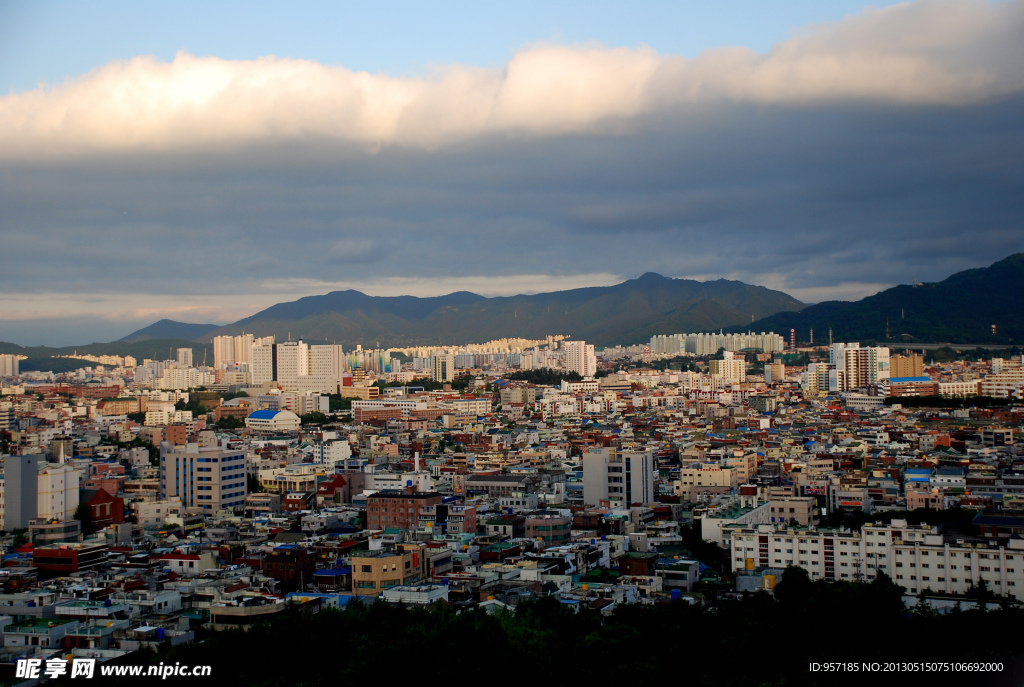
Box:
xmin=197 ymin=272 xmax=804 ymax=347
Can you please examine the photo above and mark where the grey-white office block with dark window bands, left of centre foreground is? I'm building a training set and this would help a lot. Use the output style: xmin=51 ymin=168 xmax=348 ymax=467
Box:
xmin=160 ymin=441 xmax=246 ymax=514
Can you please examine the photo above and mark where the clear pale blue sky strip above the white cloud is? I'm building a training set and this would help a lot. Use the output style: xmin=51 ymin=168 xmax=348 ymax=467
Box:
xmin=0 ymin=0 xmax=894 ymax=93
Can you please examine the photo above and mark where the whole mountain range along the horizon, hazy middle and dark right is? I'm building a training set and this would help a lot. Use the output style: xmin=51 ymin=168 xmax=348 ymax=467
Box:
xmin=8 ymin=253 xmax=1024 ymax=370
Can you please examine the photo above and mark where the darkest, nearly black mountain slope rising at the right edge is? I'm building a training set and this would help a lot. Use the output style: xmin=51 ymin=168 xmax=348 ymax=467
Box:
xmin=735 ymin=253 xmax=1024 ymax=345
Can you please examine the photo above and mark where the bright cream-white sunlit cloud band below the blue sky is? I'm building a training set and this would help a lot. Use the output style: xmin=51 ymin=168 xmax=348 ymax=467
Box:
xmin=0 ymin=0 xmax=1024 ymax=161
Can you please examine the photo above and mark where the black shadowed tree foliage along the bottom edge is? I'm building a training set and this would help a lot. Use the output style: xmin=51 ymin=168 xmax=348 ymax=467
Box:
xmin=96 ymin=568 xmax=1024 ymax=686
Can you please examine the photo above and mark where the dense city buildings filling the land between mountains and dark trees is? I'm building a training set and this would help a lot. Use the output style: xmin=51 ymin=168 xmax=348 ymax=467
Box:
xmin=0 ymin=333 xmax=1024 ymax=671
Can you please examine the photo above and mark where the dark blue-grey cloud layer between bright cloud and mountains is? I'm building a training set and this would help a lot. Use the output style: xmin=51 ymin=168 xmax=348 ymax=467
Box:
xmin=0 ymin=3 xmax=1024 ymax=340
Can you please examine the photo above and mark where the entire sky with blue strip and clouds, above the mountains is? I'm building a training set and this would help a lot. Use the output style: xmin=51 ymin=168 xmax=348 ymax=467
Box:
xmin=0 ymin=0 xmax=1024 ymax=345
